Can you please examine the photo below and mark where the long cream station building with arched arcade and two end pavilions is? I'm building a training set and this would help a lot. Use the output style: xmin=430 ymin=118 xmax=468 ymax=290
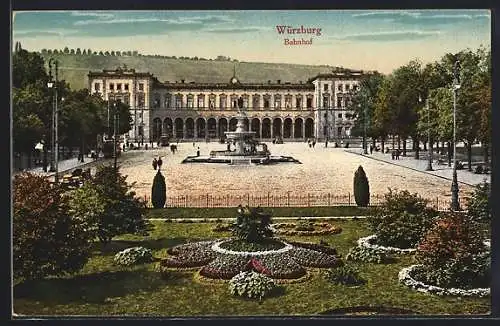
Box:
xmin=88 ymin=68 xmax=363 ymax=142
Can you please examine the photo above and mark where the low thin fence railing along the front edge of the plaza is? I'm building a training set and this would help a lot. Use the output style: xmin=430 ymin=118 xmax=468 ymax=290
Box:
xmin=144 ymin=192 xmax=465 ymax=210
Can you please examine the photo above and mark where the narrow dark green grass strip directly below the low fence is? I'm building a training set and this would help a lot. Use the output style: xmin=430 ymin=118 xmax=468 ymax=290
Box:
xmin=146 ymin=206 xmax=370 ymax=219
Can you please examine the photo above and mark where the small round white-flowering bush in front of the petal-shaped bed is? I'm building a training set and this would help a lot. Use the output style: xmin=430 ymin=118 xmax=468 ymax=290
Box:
xmin=229 ymin=271 xmax=276 ymax=300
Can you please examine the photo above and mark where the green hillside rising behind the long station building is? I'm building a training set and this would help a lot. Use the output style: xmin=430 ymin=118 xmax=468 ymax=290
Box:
xmin=40 ymin=53 xmax=346 ymax=89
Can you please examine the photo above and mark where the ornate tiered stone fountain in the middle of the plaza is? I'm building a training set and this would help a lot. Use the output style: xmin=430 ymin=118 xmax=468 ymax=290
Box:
xmin=182 ymin=97 xmax=300 ymax=165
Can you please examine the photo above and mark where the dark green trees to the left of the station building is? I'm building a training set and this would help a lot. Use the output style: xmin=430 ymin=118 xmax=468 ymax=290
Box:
xmin=12 ymin=44 xmax=132 ymax=167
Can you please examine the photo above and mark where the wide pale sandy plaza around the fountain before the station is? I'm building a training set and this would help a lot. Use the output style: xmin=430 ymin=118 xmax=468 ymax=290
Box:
xmin=119 ymin=142 xmax=484 ymax=205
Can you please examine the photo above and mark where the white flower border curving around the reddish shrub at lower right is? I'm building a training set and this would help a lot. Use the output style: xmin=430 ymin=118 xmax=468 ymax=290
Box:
xmin=398 ymin=265 xmax=490 ymax=297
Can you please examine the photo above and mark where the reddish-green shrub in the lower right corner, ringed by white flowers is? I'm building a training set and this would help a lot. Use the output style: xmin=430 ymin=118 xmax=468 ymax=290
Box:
xmin=415 ymin=212 xmax=491 ymax=288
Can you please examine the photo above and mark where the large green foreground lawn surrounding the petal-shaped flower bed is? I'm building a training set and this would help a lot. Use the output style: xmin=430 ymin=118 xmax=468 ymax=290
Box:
xmin=14 ymin=220 xmax=491 ymax=317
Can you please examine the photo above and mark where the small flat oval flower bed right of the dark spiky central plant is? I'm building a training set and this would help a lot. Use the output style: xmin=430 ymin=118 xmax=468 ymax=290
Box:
xmin=271 ymin=222 xmax=342 ymax=236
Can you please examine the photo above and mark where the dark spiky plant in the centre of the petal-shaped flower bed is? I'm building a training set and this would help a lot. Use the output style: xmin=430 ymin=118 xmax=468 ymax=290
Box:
xmin=232 ymin=205 xmax=273 ymax=242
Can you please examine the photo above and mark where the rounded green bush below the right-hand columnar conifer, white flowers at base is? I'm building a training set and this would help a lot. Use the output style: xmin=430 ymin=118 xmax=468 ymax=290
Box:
xmin=367 ymin=189 xmax=438 ymax=249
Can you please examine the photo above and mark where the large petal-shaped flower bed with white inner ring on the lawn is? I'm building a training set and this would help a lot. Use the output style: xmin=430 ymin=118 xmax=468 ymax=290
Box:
xmin=161 ymin=239 xmax=340 ymax=280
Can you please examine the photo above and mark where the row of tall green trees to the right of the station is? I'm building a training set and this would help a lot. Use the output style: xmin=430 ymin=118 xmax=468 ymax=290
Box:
xmin=348 ymin=47 xmax=491 ymax=170
